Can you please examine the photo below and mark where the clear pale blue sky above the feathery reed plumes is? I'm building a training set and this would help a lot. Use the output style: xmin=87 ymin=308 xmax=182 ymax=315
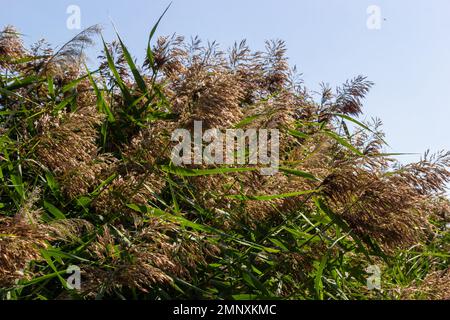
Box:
xmin=0 ymin=0 xmax=450 ymax=160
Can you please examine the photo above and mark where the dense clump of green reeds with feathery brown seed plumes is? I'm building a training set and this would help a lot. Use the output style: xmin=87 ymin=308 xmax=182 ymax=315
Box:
xmin=0 ymin=23 xmax=450 ymax=299
